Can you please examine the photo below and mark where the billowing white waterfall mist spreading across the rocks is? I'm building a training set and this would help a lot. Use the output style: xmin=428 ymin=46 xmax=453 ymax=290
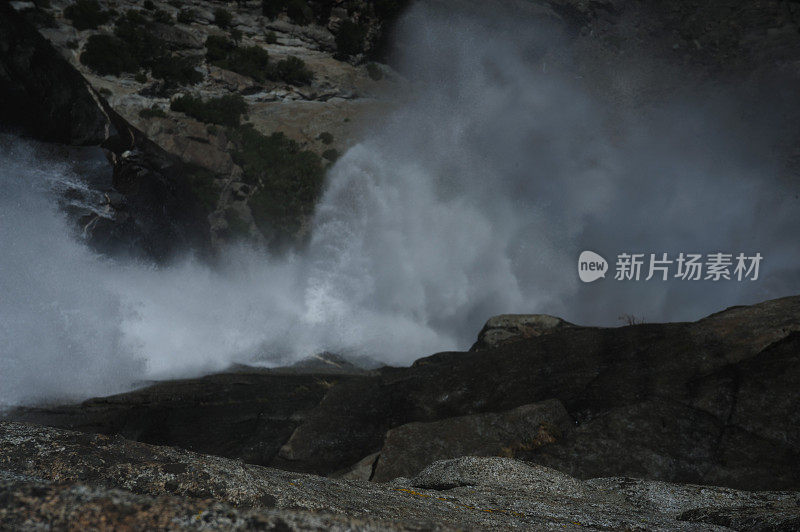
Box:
xmin=0 ymin=5 xmax=800 ymax=405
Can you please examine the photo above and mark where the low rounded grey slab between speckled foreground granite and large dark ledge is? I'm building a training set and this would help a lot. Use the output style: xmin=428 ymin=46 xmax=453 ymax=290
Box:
xmin=372 ymin=400 xmax=572 ymax=482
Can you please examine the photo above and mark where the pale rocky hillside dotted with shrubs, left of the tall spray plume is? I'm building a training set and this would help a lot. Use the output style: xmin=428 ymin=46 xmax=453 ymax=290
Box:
xmin=3 ymin=0 xmax=399 ymax=255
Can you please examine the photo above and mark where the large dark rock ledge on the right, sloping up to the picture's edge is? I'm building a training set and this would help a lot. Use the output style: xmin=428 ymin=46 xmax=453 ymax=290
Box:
xmin=274 ymin=297 xmax=800 ymax=489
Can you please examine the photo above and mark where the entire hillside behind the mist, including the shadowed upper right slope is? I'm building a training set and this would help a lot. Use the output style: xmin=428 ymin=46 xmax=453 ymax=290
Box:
xmin=6 ymin=0 xmax=800 ymax=258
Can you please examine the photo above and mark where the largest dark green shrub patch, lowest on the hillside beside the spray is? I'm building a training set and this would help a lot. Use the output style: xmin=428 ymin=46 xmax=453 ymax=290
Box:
xmin=233 ymin=127 xmax=324 ymax=242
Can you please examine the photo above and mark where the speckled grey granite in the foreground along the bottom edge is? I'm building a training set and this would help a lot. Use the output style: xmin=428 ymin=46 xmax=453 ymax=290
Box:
xmin=0 ymin=422 xmax=800 ymax=530
